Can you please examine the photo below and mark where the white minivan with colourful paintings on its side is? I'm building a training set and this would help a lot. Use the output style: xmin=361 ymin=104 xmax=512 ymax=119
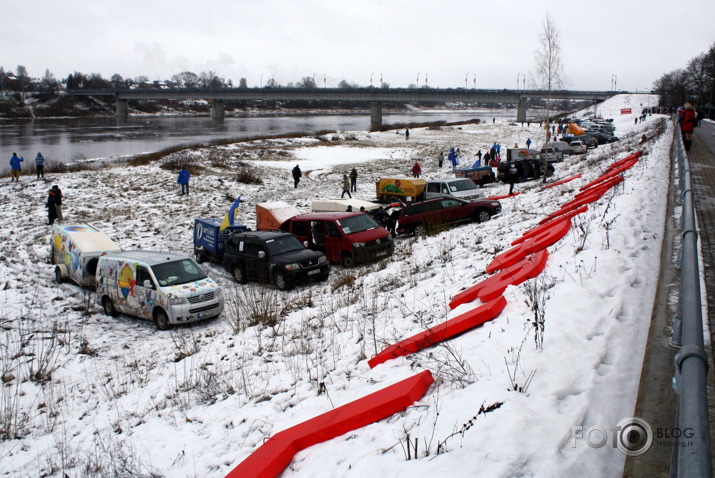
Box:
xmin=96 ymin=251 xmax=223 ymax=330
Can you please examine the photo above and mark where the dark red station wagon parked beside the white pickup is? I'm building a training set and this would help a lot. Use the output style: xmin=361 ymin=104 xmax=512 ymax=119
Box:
xmin=397 ymin=198 xmax=501 ymax=235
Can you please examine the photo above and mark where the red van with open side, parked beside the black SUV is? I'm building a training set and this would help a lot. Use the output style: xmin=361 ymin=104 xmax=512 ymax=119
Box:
xmin=280 ymin=212 xmax=395 ymax=267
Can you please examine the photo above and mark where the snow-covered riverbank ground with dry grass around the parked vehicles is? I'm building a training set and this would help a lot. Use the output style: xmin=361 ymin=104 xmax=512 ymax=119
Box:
xmin=0 ymin=95 xmax=672 ymax=477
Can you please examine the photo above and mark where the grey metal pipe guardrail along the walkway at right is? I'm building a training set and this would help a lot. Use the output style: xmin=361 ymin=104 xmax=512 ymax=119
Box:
xmin=670 ymin=121 xmax=712 ymax=478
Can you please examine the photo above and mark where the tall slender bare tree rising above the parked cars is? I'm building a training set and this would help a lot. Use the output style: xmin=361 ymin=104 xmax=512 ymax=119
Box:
xmin=535 ymin=13 xmax=564 ymax=182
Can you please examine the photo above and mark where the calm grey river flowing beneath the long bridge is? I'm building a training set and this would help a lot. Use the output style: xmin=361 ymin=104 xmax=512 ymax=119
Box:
xmin=0 ymin=109 xmax=516 ymax=162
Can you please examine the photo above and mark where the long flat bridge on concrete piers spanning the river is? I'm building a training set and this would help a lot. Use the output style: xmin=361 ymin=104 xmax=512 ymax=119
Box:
xmin=68 ymin=88 xmax=624 ymax=131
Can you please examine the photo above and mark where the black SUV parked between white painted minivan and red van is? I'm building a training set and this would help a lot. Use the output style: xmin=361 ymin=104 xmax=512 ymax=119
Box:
xmin=223 ymin=231 xmax=330 ymax=290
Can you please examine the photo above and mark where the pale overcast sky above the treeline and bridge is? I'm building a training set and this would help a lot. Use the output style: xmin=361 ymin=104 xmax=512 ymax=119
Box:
xmin=0 ymin=0 xmax=715 ymax=91
